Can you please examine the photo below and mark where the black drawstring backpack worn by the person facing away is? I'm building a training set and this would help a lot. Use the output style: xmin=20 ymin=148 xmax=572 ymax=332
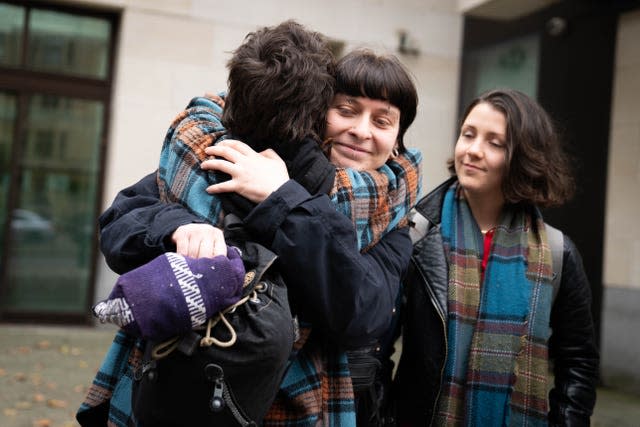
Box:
xmin=131 ymin=215 xmax=294 ymax=427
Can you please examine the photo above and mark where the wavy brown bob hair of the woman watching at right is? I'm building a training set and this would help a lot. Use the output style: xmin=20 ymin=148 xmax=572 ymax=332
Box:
xmin=448 ymin=89 xmax=575 ymax=207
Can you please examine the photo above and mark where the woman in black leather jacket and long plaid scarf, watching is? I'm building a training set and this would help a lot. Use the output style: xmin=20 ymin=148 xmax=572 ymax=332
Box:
xmin=394 ymin=89 xmax=599 ymax=426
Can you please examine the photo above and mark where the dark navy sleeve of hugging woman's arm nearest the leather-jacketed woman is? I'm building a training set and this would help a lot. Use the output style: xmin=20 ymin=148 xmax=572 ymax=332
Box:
xmin=245 ymin=180 xmax=411 ymax=347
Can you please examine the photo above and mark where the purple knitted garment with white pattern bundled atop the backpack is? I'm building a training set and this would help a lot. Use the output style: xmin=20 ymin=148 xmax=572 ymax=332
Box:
xmin=93 ymin=247 xmax=245 ymax=341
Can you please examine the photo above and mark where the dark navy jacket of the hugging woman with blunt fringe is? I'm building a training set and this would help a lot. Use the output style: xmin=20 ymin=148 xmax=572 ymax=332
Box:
xmin=99 ymin=173 xmax=411 ymax=348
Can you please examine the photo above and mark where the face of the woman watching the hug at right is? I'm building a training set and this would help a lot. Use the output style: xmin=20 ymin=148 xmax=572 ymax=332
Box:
xmin=454 ymin=102 xmax=507 ymax=198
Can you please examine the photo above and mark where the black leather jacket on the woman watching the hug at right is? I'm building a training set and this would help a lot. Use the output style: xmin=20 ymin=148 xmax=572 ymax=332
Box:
xmin=394 ymin=178 xmax=599 ymax=426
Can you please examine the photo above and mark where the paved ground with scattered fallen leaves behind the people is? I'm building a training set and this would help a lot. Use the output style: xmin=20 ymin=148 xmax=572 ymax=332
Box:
xmin=0 ymin=324 xmax=640 ymax=427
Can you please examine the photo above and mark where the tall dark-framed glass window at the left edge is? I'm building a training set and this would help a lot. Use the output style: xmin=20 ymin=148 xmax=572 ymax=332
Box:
xmin=0 ymin=1 xmax=117 ymax=319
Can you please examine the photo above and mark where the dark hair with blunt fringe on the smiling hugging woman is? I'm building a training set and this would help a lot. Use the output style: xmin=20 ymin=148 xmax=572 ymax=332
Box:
xmin=336 ymin=49 xmax=418 ymax=153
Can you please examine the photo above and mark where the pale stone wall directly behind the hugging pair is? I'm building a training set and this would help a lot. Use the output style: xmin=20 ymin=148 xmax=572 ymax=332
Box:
xmin=74 ymin=0 xmax=462 ymax=299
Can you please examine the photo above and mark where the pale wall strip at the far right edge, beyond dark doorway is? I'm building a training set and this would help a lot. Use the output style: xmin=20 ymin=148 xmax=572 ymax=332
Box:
xmin=601 ymin=11 xmax=640 ymax=394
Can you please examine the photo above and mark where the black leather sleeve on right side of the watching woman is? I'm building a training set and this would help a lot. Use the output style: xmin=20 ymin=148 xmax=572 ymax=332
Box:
xmin=549 ymin=235 xmax=599 ymax=426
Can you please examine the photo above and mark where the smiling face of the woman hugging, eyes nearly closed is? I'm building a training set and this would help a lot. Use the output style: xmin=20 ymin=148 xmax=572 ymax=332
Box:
xmin=325 ymin=94 xmax=400 ymax=170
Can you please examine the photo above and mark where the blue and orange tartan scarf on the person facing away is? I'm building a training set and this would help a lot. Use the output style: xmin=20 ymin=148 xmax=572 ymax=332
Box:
xmin=77 ymin=94 xmax=422 ymax=427
